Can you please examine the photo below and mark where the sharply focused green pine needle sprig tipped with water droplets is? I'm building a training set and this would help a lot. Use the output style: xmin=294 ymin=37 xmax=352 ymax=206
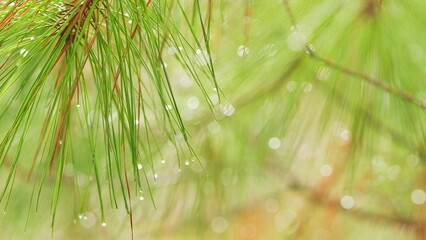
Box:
xmin=0 ymin=0 xmax=220 ymax=233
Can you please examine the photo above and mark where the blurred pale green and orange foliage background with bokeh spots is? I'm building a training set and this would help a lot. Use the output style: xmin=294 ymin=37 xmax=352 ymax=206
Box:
xmin=0 ymin=0 xmax=426 ymax=239
